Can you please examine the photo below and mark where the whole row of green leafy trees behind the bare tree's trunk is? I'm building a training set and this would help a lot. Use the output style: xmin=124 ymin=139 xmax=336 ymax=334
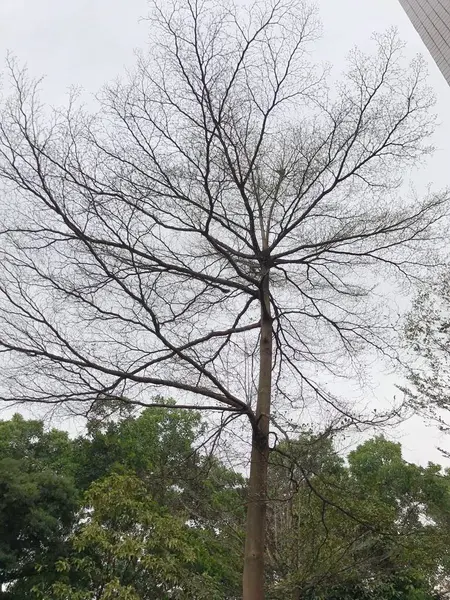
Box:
xmin=0 ymin=407 xmax=450 ymax=600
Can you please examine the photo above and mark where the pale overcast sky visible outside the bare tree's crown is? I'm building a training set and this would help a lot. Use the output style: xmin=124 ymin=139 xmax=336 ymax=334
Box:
xmin=0 ymin=0 xmax=450 ymax=464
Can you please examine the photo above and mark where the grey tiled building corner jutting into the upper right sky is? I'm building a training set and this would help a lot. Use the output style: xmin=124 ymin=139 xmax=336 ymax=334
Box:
xmin=400 ymin=0 xmax=450 ymax=85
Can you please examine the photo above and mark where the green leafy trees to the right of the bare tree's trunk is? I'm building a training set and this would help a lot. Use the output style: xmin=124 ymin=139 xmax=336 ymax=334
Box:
xmin=269 ymin=436 xmax=450 ymax=600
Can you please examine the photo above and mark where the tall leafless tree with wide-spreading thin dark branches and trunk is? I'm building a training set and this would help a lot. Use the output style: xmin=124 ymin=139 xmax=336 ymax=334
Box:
xmin=0 ymin=0 xmax=447 ymax=600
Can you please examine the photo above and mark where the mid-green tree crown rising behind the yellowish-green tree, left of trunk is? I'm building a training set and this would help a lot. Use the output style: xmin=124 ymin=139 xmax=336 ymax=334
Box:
xmin=75 ymin=401 xmax=245 ymax=527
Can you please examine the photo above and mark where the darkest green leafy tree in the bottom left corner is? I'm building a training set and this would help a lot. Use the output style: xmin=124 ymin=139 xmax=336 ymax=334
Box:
xmin=0 ymin=449 xmax=78 ymax=599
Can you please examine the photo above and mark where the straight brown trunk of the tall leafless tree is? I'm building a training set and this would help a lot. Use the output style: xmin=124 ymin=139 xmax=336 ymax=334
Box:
xmin=242 ymin=273 xmax=273 ymax=600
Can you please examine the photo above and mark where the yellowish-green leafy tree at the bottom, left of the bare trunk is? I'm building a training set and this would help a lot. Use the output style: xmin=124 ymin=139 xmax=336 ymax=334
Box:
xmin=36 ymin=474 xmax=239 ymax=600
